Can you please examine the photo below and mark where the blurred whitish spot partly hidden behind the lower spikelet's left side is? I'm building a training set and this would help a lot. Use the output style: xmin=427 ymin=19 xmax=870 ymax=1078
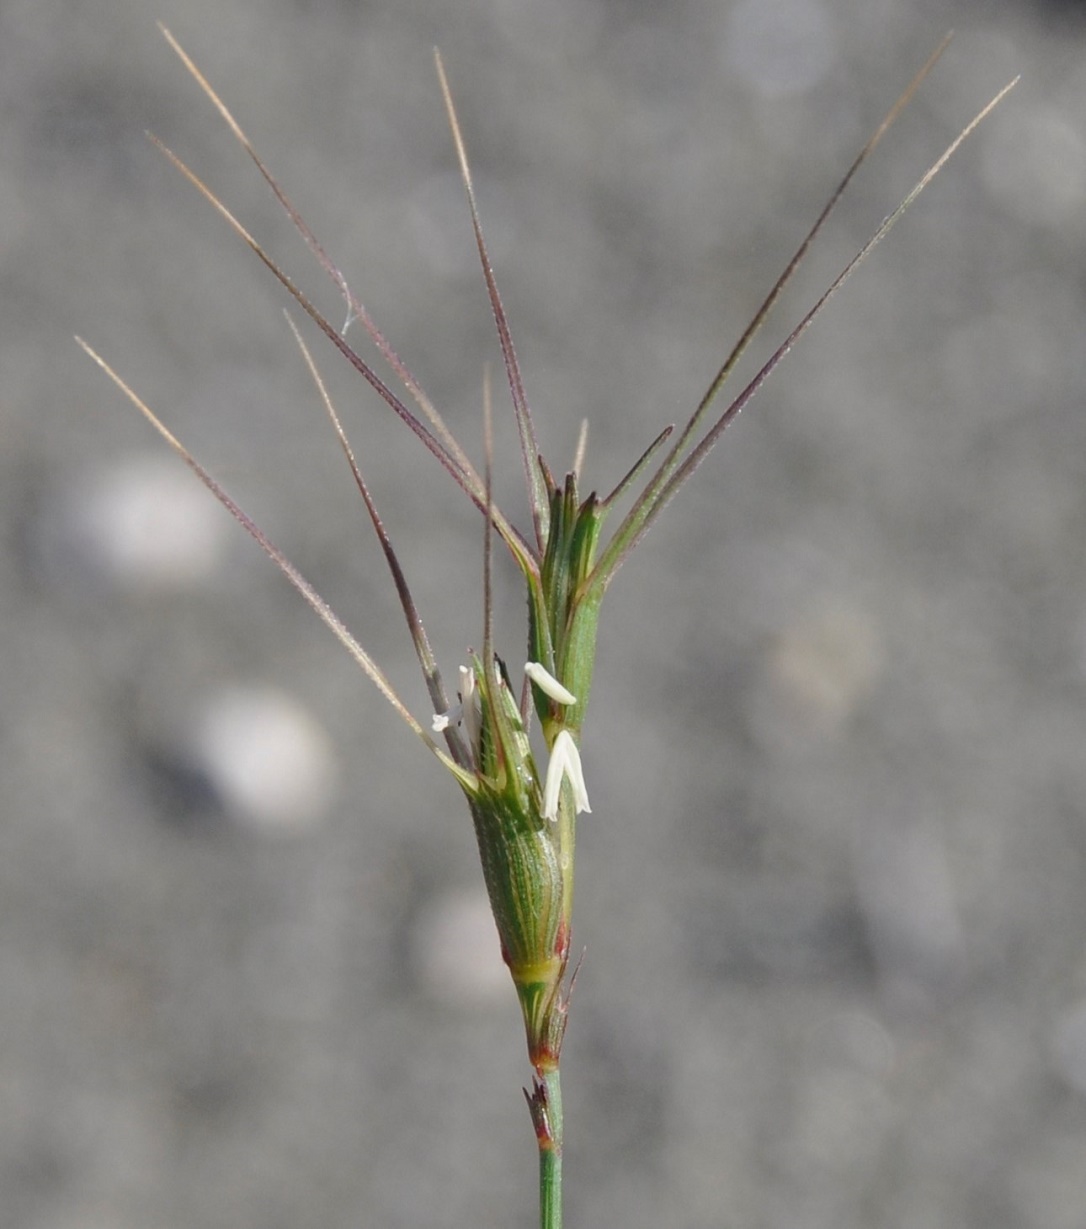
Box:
xmin=412 ymin=889 xmax=509 ymax=1007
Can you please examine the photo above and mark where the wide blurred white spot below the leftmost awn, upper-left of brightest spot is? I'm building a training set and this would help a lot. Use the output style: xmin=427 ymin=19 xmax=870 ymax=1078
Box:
xmin=77 ymin=457 xmax=230 ymax=585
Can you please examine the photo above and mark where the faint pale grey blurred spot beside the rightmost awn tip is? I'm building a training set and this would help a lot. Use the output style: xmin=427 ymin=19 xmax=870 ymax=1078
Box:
xmin=983 ymin=106 xmax=1086 ymax=226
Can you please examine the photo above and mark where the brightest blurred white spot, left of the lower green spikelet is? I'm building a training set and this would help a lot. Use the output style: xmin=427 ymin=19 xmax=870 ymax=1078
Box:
xmin=193 ymin=687 xmax=337 ymax=831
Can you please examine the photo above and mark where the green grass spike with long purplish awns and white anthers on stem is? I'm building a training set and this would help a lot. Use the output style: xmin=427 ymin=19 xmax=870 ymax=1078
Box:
xmin=80 ymin=29 xmax=1015 ymax=1229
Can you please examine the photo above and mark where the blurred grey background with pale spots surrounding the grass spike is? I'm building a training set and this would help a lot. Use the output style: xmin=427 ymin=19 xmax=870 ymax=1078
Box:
xmin=0 ymin=0 xmax=1086 ymax=1229
